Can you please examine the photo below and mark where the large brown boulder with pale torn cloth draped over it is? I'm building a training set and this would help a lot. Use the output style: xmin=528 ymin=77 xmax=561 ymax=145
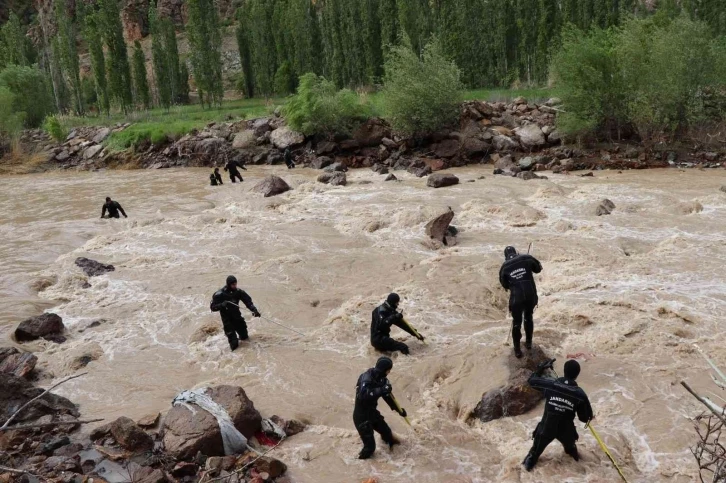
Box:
xmin=161 ymin=386 xmax=262 ymax=459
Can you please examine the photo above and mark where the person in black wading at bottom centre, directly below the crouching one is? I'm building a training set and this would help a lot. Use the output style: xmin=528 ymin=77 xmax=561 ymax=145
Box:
xmin=353 ymin=357 xmax=407 ymax=460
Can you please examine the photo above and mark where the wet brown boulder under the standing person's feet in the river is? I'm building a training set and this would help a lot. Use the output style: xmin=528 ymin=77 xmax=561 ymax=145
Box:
xmin=469 ymin=345 xmax=550 ymax=423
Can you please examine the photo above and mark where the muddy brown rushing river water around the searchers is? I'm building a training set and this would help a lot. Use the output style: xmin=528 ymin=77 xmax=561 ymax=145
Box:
xmin=0 ymin=168 xmax=726 ymax=483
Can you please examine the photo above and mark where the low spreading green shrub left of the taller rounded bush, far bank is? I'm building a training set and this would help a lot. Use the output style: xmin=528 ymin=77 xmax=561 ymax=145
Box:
xmin=283 ymin=73 xmax=370 ymax=135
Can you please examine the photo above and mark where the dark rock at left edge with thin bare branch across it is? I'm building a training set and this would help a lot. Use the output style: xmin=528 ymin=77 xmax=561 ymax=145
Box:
xmin=0 ymin=373 xmax=80 ymax=423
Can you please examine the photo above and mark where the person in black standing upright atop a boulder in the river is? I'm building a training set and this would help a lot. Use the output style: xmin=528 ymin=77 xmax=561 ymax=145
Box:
xmin=499 ymin=247 xmax=542 ymax=358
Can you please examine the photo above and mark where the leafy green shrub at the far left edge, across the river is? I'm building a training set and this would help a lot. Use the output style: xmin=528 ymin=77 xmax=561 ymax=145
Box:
xmin=0 ymin=65 xmax=54 ymax=128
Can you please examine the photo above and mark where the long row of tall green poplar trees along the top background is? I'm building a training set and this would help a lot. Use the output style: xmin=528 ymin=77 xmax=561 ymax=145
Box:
xmin=0 ymin=0 xmax=726 ymax=114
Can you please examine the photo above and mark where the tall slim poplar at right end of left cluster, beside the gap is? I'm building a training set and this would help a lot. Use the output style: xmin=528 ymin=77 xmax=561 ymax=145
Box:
xmin=187 ymin=0 xmax=224 ymax=106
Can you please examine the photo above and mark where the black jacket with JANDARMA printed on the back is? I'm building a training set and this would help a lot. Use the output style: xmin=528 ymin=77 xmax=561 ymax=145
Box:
xmin=528 ymin=372 xmax=593 ymax=426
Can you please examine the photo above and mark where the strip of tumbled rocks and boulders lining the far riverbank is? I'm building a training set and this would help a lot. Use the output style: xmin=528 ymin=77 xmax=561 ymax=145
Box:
xmin=12 ymin=97 xmax=726 ymax=176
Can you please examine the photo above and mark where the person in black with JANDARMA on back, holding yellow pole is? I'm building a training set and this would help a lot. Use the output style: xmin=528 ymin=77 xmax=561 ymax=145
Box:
xmin=522 ymin=359 xmax=593 ymax=471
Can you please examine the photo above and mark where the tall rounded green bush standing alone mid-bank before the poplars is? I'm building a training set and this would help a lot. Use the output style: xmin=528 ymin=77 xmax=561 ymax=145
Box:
xmin=382 ymin=39 xmax=463 ymax=135
